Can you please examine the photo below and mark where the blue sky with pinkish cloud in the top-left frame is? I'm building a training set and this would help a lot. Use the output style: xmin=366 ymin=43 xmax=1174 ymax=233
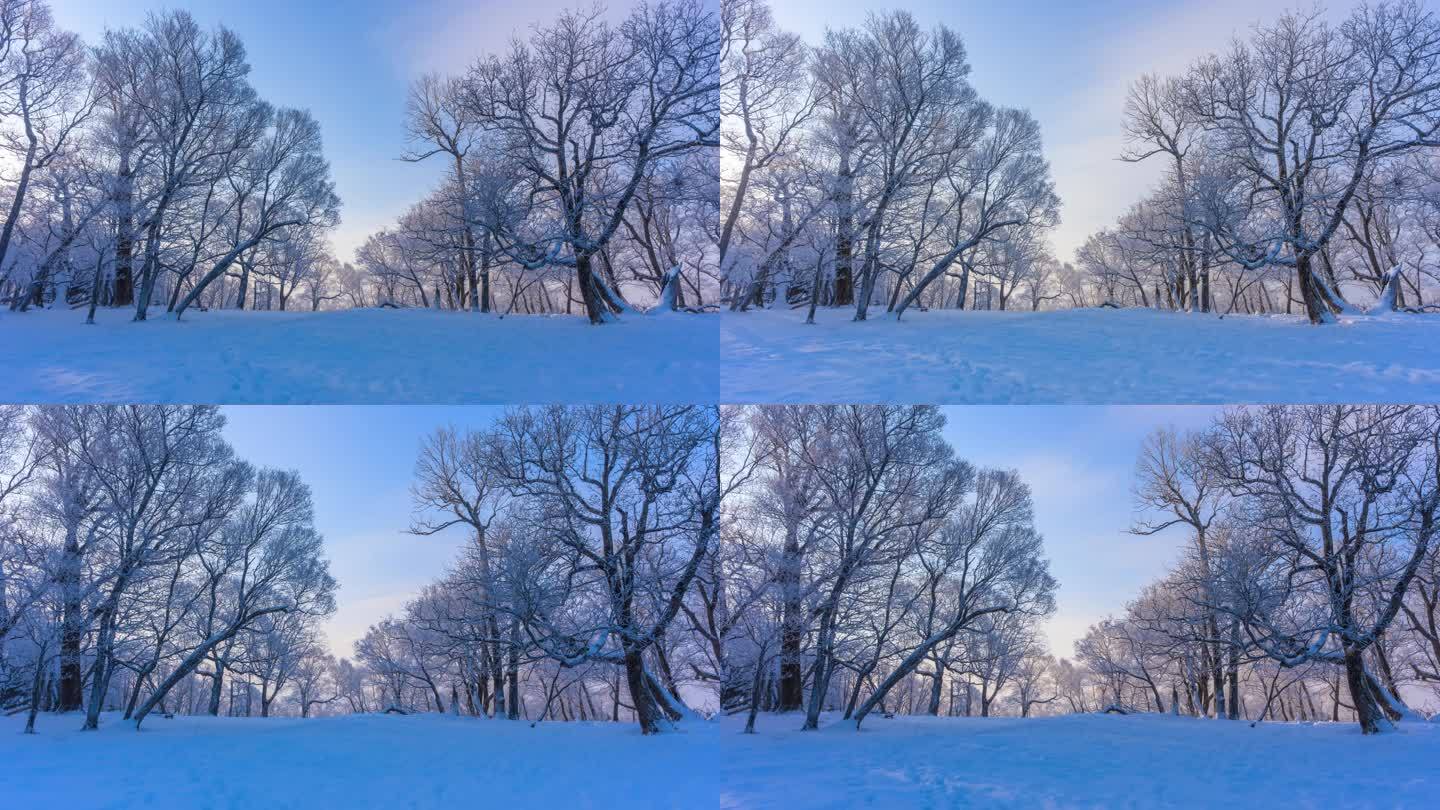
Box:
xmin=50 ymin=0 xmax=648 ymax=261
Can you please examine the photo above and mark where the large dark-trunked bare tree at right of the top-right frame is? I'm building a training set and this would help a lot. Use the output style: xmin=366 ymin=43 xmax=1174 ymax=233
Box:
xmin=1184 ymin=0 xmax=1440 ymax=323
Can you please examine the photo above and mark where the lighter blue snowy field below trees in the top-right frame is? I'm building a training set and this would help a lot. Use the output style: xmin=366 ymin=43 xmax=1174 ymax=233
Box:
xmin=720 ymin=304 xmax=1440 ymax=404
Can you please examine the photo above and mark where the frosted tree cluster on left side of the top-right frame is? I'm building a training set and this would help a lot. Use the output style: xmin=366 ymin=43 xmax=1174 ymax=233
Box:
xmin=720 ymin=0 xmax=1060 ymax=320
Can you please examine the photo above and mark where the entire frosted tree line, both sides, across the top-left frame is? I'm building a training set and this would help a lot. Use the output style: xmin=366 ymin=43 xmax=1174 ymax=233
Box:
xmin=0 ymin=0 xmax=720 ymax=323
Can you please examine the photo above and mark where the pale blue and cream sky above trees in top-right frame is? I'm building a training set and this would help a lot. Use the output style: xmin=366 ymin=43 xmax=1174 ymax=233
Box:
xmin=770 ymin=0 xmax=1354 ymax=261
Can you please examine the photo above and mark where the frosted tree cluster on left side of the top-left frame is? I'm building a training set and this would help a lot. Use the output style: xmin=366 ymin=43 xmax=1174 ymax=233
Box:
xmin=0 ymin=0 xmax=343 ymax=320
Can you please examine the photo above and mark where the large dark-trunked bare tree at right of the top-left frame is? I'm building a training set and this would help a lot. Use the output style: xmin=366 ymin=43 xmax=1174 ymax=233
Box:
xmin=465 ymin=0 xmax=720 ymax=323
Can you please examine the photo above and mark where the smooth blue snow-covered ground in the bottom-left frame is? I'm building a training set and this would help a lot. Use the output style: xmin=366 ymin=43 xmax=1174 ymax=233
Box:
xmin=0 ymin=715 xmax=720 ymax=810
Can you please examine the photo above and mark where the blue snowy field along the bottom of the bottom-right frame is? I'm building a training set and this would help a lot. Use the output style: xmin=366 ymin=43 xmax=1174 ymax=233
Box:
xmin=720 ymin=715 xmax=1440 ymax=810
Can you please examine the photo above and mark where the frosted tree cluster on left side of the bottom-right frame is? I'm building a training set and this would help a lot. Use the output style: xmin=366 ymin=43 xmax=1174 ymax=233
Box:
xmin=721 ymin=405 xmax=1057 ymax=731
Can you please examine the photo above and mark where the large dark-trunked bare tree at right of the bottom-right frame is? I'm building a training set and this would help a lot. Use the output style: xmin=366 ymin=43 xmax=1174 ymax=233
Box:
xmin=1205 ymin=406 xmax=1440 ymax=734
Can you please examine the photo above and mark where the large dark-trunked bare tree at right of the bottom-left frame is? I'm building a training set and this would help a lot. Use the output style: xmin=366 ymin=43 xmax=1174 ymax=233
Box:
xmin=488 ymin=405 xmax=720 ymax=734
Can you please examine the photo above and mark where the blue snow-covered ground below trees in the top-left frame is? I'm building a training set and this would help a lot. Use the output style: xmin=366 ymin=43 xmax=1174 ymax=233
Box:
xmin=0 ymin=310 xmax=720 ymax=404
